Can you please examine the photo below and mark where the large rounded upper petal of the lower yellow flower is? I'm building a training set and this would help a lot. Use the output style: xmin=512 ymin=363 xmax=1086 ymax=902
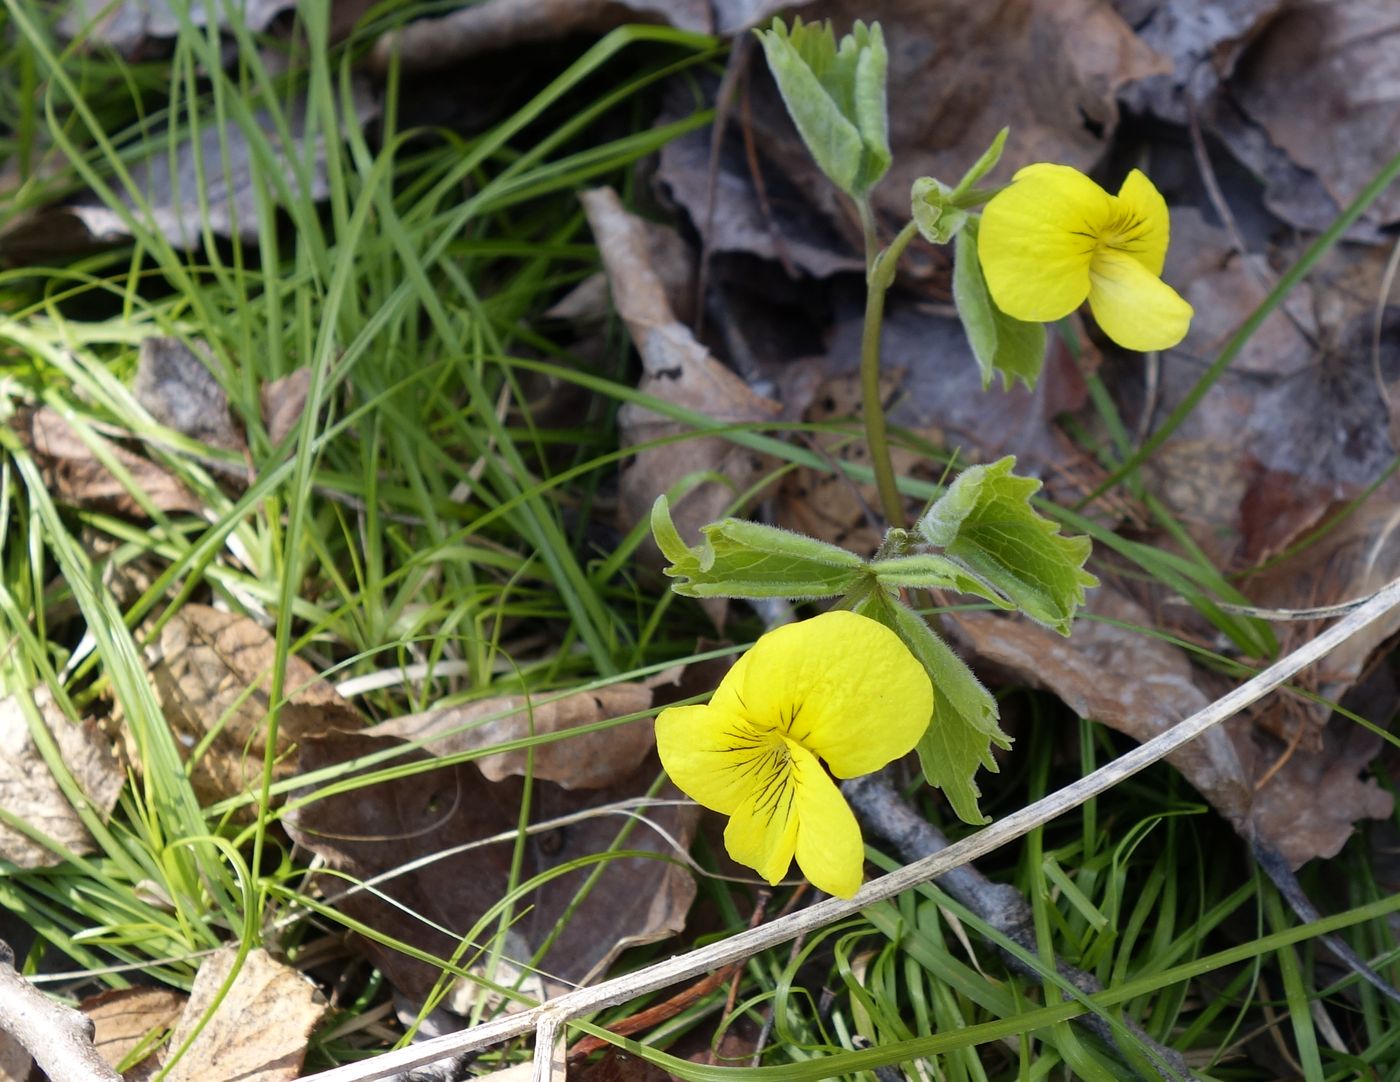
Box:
xmin=722 ymin=610 xmax=934 ymax=788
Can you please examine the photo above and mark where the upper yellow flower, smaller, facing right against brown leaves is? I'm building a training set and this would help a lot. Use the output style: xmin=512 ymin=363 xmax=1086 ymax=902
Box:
xmin=977 ymin=162 xmax=1191 ymax=350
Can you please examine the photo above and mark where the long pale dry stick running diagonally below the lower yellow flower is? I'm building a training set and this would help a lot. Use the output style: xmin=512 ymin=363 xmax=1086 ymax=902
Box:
xmin=298 ymin=579 xmax=1400 ymax=1082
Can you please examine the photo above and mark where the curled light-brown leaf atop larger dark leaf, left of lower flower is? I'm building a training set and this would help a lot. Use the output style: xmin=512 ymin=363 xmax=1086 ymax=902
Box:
xmin=365 ymin=683 xmax=657 ymax=789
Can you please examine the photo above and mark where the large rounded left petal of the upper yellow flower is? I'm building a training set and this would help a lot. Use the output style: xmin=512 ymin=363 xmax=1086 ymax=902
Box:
xmin=977 ymin=162 xmax=1113 ymax=323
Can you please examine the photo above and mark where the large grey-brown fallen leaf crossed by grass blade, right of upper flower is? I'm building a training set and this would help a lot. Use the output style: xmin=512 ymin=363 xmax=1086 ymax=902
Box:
xmin=1120 ymin=211 xmax=1400 ymax=570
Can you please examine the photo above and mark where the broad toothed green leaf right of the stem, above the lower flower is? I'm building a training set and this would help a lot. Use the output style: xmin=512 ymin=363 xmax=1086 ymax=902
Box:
xmin=918 ymin=455 xmax=1099 ymax=635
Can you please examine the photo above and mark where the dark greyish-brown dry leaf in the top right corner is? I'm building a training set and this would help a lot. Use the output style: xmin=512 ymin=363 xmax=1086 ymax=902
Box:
xmin=1231 ymin=0 xmax=1400 ymax=224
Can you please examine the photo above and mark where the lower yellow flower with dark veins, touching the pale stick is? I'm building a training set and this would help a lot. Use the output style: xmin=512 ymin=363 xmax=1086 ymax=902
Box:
xmin=657 ymin=610 xmax=934 ymax=897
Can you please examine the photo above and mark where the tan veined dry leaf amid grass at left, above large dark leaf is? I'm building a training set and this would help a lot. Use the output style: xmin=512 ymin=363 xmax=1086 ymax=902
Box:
xmin=146 ymin=605 xmax=358 ymax=801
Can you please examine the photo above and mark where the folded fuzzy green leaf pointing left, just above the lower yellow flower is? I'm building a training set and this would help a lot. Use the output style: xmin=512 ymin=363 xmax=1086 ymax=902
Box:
xmin=651 ymin=496 xmax=867 ymax=598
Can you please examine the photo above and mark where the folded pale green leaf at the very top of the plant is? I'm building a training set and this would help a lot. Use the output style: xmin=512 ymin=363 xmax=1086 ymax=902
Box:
xmin=755 ymin=18 xmax=890 ymax=199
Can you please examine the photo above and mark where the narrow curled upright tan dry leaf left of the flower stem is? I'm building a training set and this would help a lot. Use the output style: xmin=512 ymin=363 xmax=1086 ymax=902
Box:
xmin=580 ymin=188 xmax=781 ymax=613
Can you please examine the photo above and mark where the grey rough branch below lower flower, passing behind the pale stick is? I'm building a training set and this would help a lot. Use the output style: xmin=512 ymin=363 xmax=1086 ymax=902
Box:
xmin=841 ymin=774 xmax=1194 ymax=1079
